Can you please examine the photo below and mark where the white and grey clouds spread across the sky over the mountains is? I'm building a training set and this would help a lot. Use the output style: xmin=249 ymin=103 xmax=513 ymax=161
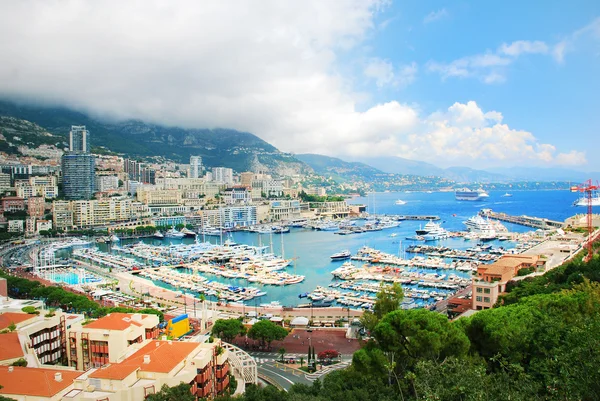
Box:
xmin=0 ymin=0 xmax=575 ymax=166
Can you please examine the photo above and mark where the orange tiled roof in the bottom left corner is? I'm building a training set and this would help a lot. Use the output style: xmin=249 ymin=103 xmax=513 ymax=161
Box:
xmin=0 ymin=366 xmax=83 ymax=397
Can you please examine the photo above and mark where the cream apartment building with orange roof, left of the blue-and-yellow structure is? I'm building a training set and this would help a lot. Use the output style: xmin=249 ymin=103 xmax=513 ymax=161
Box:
xmin=67 ymin=313 xmax=159 ymax=370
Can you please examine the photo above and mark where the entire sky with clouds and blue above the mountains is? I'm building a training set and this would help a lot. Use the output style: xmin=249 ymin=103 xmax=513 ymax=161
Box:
xmin=0 ymin=0 xmax=600 ymax=171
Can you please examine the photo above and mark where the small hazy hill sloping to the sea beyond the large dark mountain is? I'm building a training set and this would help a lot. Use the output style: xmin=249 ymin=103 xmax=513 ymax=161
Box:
xmin=295 ymin=153 xmax=386 ymax=181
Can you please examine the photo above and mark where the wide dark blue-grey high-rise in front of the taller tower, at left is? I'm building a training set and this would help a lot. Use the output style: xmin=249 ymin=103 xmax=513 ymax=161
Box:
xmin=61 ymin=153 xmax=96 ymax=199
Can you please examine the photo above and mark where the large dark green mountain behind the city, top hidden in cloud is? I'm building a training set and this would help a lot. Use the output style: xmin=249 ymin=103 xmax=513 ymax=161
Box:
xmin=0 ymin=101 xmax=310 ymax=175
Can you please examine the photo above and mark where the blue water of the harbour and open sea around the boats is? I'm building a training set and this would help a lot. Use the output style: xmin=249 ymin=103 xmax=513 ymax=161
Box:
xmin=83 ymin=190 xmax=598 ymax=306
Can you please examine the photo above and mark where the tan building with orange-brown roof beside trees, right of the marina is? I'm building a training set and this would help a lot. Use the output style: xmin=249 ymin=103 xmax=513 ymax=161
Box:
xmin=472 ymin=255 xmax=545 ymax=310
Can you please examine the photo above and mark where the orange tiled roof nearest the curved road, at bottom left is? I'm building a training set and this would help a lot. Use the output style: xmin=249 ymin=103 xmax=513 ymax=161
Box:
xmin=90 ymin=341 xmax=200 ymax=380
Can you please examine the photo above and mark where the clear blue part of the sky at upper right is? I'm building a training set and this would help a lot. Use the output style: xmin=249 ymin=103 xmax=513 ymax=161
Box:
xmin=360 ymin=1 xmax=600 ymax=171
